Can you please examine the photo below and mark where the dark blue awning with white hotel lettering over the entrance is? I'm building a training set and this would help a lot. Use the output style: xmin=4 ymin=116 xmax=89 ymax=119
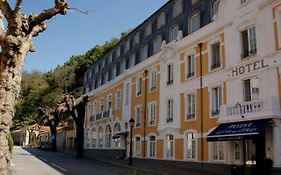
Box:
xmin=207 ymin=119 xmax=271 ymax=141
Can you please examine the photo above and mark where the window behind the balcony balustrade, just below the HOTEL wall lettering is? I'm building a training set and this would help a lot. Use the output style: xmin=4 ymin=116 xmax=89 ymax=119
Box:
xmin=243 ymin=77 xmax=259 ymax=102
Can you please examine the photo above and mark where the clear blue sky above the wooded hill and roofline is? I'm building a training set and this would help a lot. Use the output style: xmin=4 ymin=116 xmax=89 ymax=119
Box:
xmin=22 ymin=0 xmax=168 ymax=72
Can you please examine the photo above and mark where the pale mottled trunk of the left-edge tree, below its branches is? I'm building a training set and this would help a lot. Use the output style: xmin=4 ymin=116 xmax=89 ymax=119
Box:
xmin=0 ymin=54 xmax=25 ymax=175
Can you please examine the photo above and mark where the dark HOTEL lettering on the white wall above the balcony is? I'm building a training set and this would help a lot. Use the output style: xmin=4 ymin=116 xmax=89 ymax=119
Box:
xmin=229 ymin=59 xmax=268 ymax=77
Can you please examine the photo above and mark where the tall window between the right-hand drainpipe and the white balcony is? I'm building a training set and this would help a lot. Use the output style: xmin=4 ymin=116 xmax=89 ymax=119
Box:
xmin=212 ymin=87 xmax=222 ymax=116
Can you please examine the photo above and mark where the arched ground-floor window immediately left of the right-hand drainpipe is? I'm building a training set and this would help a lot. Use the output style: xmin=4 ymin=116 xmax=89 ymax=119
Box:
xmin=186 ymin=132 xmax=196 ymax=160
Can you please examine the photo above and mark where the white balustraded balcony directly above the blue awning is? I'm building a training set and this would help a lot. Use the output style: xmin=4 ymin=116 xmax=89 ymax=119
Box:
xmin=219 ymin=97 xmax=281 ymax=123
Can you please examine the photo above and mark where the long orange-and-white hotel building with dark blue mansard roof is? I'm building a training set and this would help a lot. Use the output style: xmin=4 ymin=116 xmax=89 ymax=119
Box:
xmin=83 ymin=0 xmax=281 ymax=174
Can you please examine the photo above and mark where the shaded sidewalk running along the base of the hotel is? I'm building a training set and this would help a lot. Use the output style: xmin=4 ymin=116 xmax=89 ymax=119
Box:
xmin=59 ymin=150 xmax=228 ymax=175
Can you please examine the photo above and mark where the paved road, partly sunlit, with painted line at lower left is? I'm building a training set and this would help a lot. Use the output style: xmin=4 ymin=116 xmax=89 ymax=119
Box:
xmin=13 ymin=147 xmax=153 ymax=175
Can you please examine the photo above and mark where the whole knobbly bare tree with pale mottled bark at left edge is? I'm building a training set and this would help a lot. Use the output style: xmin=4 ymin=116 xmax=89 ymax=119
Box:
xmin=0 ymin=0 xmax=68 ymax=175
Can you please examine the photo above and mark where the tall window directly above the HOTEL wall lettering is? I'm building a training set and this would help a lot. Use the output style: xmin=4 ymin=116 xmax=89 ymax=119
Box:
xmin=241 ymin=26 xmax=257 ymax=59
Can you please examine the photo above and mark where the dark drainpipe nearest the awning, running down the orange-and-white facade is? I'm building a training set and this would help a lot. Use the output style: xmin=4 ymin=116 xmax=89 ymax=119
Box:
xmin=198 ymin=43 xmax=204 ymax=174
